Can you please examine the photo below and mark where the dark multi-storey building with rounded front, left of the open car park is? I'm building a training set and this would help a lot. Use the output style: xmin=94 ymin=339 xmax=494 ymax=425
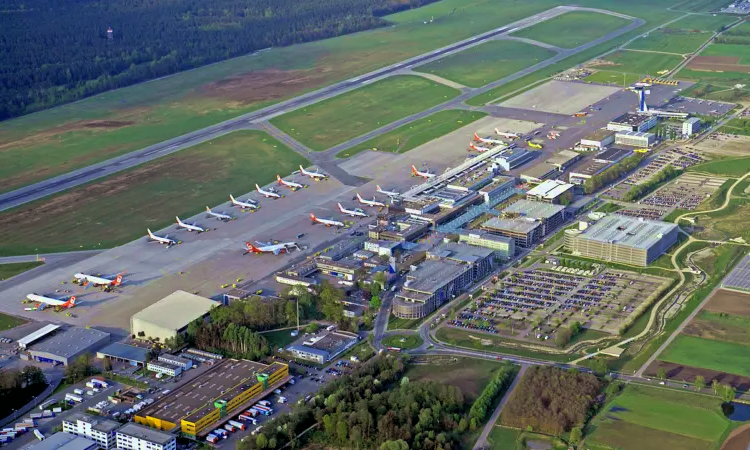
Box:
xmin=393 ymin=244 xmax=494 ymax=319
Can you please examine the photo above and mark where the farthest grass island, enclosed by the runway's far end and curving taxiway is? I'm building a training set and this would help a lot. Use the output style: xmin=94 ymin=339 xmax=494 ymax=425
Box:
xmin=512 ymin=11 xmax=630 ymax=48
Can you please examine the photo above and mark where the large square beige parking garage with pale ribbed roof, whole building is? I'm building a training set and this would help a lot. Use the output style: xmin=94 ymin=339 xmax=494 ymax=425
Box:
xmin=564 ymin=215 xmax=678 ymax=267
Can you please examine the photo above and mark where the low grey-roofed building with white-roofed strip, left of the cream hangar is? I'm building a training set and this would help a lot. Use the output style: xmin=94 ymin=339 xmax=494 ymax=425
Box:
xmin=19 ymin=326 xmax=110 ymax=366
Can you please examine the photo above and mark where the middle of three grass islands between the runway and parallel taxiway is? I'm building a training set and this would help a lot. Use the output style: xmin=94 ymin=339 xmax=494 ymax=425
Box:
xmin=417 ymin=41 xmax=555 ymax=88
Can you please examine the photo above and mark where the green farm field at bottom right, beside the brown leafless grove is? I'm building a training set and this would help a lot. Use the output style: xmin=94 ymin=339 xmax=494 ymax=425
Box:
xmin=587 ymin=384 xmax=730 ymax=450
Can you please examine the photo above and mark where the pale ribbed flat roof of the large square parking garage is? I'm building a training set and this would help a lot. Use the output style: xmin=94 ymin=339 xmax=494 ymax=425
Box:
xmin=579 ymin=214 xmax=677 ymax=250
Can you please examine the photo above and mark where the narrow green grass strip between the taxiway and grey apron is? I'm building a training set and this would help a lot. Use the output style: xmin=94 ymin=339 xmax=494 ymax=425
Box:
xmin=336 ymin=109 xmax=487 ymax=158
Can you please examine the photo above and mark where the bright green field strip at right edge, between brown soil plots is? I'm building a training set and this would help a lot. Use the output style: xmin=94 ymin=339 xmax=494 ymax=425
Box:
xmin=659 ymin=335 xmax=750 ymax=376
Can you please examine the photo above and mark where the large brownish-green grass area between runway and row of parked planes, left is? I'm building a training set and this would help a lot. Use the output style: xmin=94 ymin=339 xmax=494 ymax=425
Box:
xmin=0 ymin=131 xmax=307 ymax=255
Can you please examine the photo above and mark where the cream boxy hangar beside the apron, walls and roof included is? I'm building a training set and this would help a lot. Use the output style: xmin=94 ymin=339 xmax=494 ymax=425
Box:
xmin=130 ymin=291 xmax=219 ymax=342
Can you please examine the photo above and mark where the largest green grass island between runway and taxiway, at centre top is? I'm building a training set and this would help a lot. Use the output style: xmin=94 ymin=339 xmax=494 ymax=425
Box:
xmin=271 ymin=75 xmax=460 ymax=151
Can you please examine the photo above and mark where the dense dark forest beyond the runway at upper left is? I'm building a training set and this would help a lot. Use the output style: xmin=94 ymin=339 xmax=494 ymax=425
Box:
xmin=0 ymin=0 xmax=436 ymax=120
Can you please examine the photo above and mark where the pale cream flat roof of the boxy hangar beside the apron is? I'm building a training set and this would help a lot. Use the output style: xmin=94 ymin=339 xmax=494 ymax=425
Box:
xmin=133 ymin=291 xmax=219 ymax=330
